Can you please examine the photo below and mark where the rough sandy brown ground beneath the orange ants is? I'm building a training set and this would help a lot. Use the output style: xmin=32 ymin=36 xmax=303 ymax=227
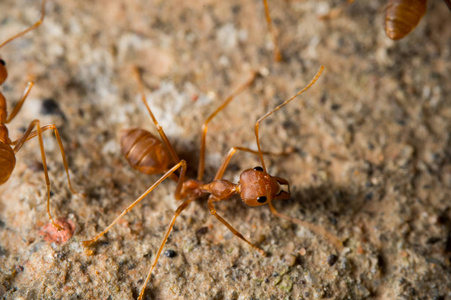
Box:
xmin=0 ymin=0 xmax=451 ymax=300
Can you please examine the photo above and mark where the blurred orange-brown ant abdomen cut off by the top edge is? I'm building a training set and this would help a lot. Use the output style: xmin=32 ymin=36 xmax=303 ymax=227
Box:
xmin=385 ymin=0 xmax=427 ymax=40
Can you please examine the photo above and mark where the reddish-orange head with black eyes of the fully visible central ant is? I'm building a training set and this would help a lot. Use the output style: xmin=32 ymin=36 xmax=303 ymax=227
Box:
xmin=240 ymin=167 xmax=290 ymax=206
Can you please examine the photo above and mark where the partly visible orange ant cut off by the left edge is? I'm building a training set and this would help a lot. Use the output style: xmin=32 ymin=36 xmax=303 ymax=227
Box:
xmin=0 ymin=0 xmax=82 ymax=230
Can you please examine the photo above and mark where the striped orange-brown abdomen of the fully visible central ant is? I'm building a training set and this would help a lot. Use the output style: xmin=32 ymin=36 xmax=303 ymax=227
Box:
xmin=121 ymin=128 xmax=170 ymax=174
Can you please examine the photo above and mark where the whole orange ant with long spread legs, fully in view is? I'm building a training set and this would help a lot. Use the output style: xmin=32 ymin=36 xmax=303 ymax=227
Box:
xmin=82 ymin=66 xmax=343 ymax=300
